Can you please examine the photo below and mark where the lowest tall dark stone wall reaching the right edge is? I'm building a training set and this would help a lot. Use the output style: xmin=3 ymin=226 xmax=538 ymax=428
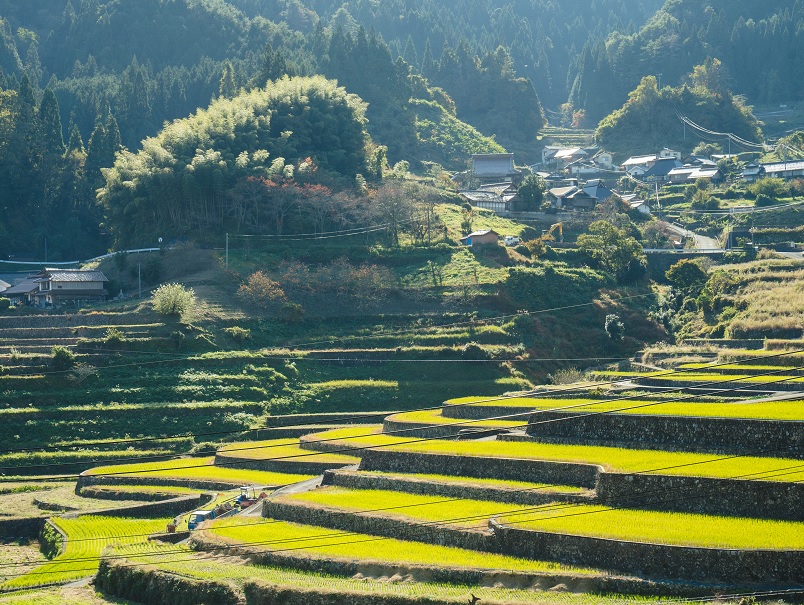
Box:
xmin=491 ymin=520 xmax=804 ymax=584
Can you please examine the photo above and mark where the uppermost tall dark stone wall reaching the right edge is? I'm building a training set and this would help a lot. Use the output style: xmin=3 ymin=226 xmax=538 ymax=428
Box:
xmin=527 ymin=406 xmax=804 ymax=459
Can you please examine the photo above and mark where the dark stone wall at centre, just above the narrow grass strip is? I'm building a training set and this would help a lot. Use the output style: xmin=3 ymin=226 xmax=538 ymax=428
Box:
xmin=360 ymin=450 xmax=600 ymax=488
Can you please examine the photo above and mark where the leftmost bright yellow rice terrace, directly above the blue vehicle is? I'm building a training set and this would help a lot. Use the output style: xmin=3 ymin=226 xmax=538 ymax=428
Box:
xmin=88 ymin=456 xmax=312 ymax=486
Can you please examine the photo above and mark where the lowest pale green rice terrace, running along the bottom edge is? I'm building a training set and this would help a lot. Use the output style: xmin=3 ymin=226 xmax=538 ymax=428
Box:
xmin=107 ymin=546 xmax=657 ymax=605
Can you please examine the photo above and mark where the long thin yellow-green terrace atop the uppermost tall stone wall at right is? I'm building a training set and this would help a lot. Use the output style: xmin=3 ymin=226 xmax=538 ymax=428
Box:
xmin=447 ymin=397 xmax=804 ymax=420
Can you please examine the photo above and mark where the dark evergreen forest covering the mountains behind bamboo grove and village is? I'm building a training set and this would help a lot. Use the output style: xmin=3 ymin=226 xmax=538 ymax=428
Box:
xmin=0 ymin=0 xmax=804 ymax=260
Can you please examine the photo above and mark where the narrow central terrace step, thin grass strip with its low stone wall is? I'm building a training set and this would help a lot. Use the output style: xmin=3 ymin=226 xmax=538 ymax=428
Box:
xmin=322 ymin=470 xmax=594 ymax=506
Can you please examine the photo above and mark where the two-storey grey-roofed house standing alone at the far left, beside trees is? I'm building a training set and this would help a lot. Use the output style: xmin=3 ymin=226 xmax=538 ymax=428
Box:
xmin=25 ymin=269 xmax=109 ymax=307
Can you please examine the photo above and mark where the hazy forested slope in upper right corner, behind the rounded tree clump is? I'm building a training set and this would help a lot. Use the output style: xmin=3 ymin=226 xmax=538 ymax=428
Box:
xmin=570 ymin=0 xmax=804 ymax=120
